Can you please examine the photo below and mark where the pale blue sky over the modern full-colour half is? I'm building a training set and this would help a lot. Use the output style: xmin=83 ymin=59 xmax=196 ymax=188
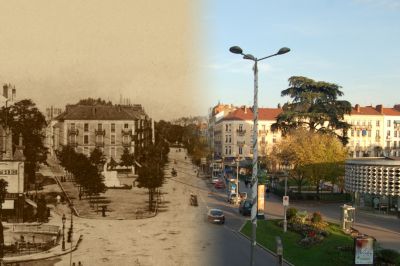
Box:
xmin=202 ymin=0 xmax=400 ymax=111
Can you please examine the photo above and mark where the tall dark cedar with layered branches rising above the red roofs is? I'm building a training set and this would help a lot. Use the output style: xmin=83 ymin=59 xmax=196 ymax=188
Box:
xmin=272 ymin=76 xmax=351 ymax=144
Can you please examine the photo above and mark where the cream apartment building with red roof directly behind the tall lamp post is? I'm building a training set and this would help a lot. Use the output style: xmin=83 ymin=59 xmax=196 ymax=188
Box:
xmin=214 ymin=106 xmax=282 ymax=158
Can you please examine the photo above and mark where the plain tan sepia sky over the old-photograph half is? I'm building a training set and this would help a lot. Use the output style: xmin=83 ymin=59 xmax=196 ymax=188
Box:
xmin=0 ymin=0 xmax=207 ymax=120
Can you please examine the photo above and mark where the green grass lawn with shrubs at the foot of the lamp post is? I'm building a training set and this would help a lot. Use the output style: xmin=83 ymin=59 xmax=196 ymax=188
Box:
xmin=242 ymin=220 xmax=353 ymax=266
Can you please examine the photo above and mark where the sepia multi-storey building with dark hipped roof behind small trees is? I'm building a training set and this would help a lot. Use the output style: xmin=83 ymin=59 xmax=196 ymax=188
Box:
xmin=52 ymin=105 xmax=152 ymax=165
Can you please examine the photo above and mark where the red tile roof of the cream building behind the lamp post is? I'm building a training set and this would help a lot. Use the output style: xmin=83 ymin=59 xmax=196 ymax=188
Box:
xmin=221 ymin=107 xmax=282 ymax=121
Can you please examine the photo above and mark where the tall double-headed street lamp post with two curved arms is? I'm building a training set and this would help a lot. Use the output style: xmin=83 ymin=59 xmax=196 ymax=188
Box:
xmin=229 ymin=46 xmax=290 ymax=266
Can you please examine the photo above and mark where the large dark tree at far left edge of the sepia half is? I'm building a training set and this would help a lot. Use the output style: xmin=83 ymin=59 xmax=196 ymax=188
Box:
xmin=0 ymin=99 xmax=47 ymax=183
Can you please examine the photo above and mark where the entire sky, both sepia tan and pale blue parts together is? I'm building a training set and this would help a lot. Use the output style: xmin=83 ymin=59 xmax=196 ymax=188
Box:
xmin=0 ymin=0 xmax=400 ymax=120
